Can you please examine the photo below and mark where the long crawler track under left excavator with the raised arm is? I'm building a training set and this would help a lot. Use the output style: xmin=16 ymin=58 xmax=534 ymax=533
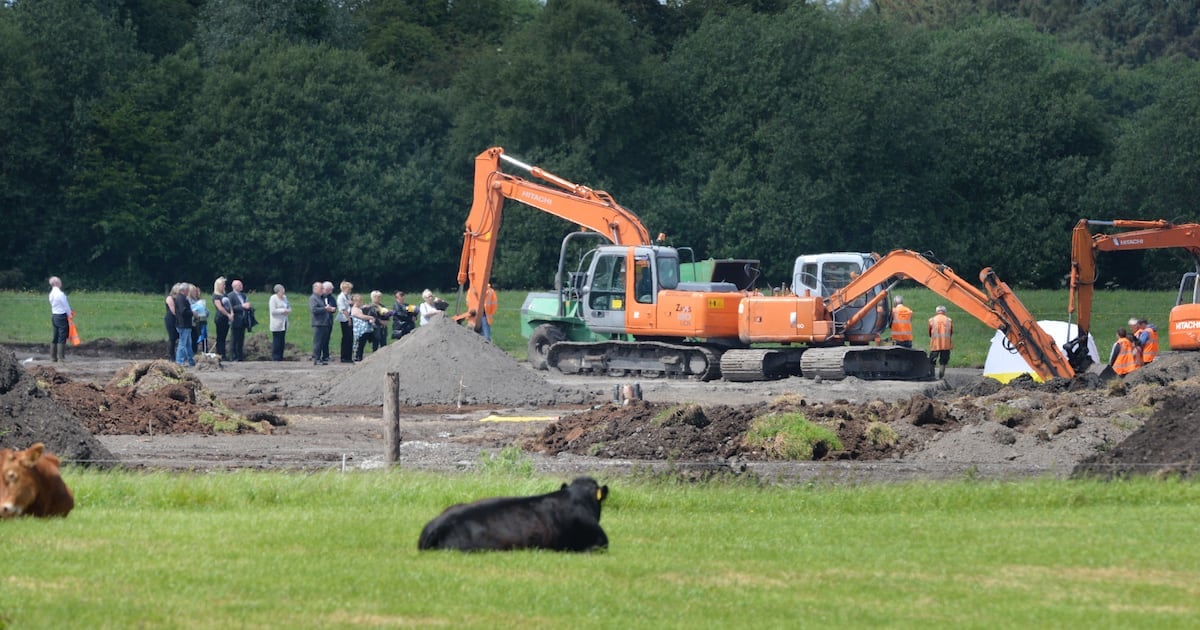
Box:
xmin=546 ymin=341 xmax=721 ymax=380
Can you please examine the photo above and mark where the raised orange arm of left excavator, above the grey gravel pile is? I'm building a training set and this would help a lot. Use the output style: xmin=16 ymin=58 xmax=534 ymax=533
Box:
xmin=456 ymin=146 xmax=650 ymax=330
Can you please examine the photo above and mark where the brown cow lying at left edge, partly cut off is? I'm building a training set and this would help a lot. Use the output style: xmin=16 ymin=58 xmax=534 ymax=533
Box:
xmin=0 ymin=442 xmax=74 ymax=518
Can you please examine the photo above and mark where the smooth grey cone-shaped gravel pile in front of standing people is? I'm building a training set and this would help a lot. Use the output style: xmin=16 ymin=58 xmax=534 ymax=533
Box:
xmin=316 ymin=318 xmax=586 ymax=406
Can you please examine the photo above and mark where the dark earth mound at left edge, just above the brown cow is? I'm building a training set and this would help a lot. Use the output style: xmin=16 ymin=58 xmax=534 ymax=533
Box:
xmin=0 ymin=346 xmax=114 ymax=466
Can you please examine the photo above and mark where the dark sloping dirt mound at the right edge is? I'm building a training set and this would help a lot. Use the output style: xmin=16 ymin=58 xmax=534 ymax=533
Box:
xmin=1074 ymin=381 xmax=1200 ymax=478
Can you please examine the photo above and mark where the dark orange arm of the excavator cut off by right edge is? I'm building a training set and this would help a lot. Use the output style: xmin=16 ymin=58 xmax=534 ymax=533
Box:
xmin=1067 ymin=218 xmax=1200 ymax=371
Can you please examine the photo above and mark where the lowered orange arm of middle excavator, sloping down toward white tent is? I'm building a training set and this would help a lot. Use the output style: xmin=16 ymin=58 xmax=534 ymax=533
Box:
xmin=824 ymin=250 xmax=1075 ymax=380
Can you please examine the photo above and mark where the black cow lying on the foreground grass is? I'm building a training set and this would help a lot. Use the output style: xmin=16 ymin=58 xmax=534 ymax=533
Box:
xmin=416 ymin=476 xmax=608 ymax=551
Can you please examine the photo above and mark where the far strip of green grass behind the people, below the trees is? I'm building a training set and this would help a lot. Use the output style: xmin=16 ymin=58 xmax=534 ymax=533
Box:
xmin=0 ymin=287 xmax=1175 ymax=367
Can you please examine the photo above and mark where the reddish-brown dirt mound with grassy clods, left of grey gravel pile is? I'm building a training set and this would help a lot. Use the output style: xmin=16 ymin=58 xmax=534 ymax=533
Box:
xmin=32 ymin=361 xmax=272 ymax=436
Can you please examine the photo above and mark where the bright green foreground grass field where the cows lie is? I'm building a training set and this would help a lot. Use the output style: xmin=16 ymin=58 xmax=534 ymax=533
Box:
xmin=0 ymin=469 xmax=1200 ymax=629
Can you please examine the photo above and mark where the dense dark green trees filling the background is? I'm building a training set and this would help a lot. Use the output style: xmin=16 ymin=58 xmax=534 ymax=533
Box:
xmin=0 ymin=0 xmax=1200 ymax=295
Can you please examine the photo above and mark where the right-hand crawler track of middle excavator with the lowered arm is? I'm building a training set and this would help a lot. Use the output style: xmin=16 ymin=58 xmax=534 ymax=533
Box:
xmin=800 ymin=346 xmax=932 ymax=380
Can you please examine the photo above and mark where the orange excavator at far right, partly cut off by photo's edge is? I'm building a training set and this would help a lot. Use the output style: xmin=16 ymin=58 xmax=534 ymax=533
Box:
xmin=1066 ymin=218 xmax=1200 ymax=371
